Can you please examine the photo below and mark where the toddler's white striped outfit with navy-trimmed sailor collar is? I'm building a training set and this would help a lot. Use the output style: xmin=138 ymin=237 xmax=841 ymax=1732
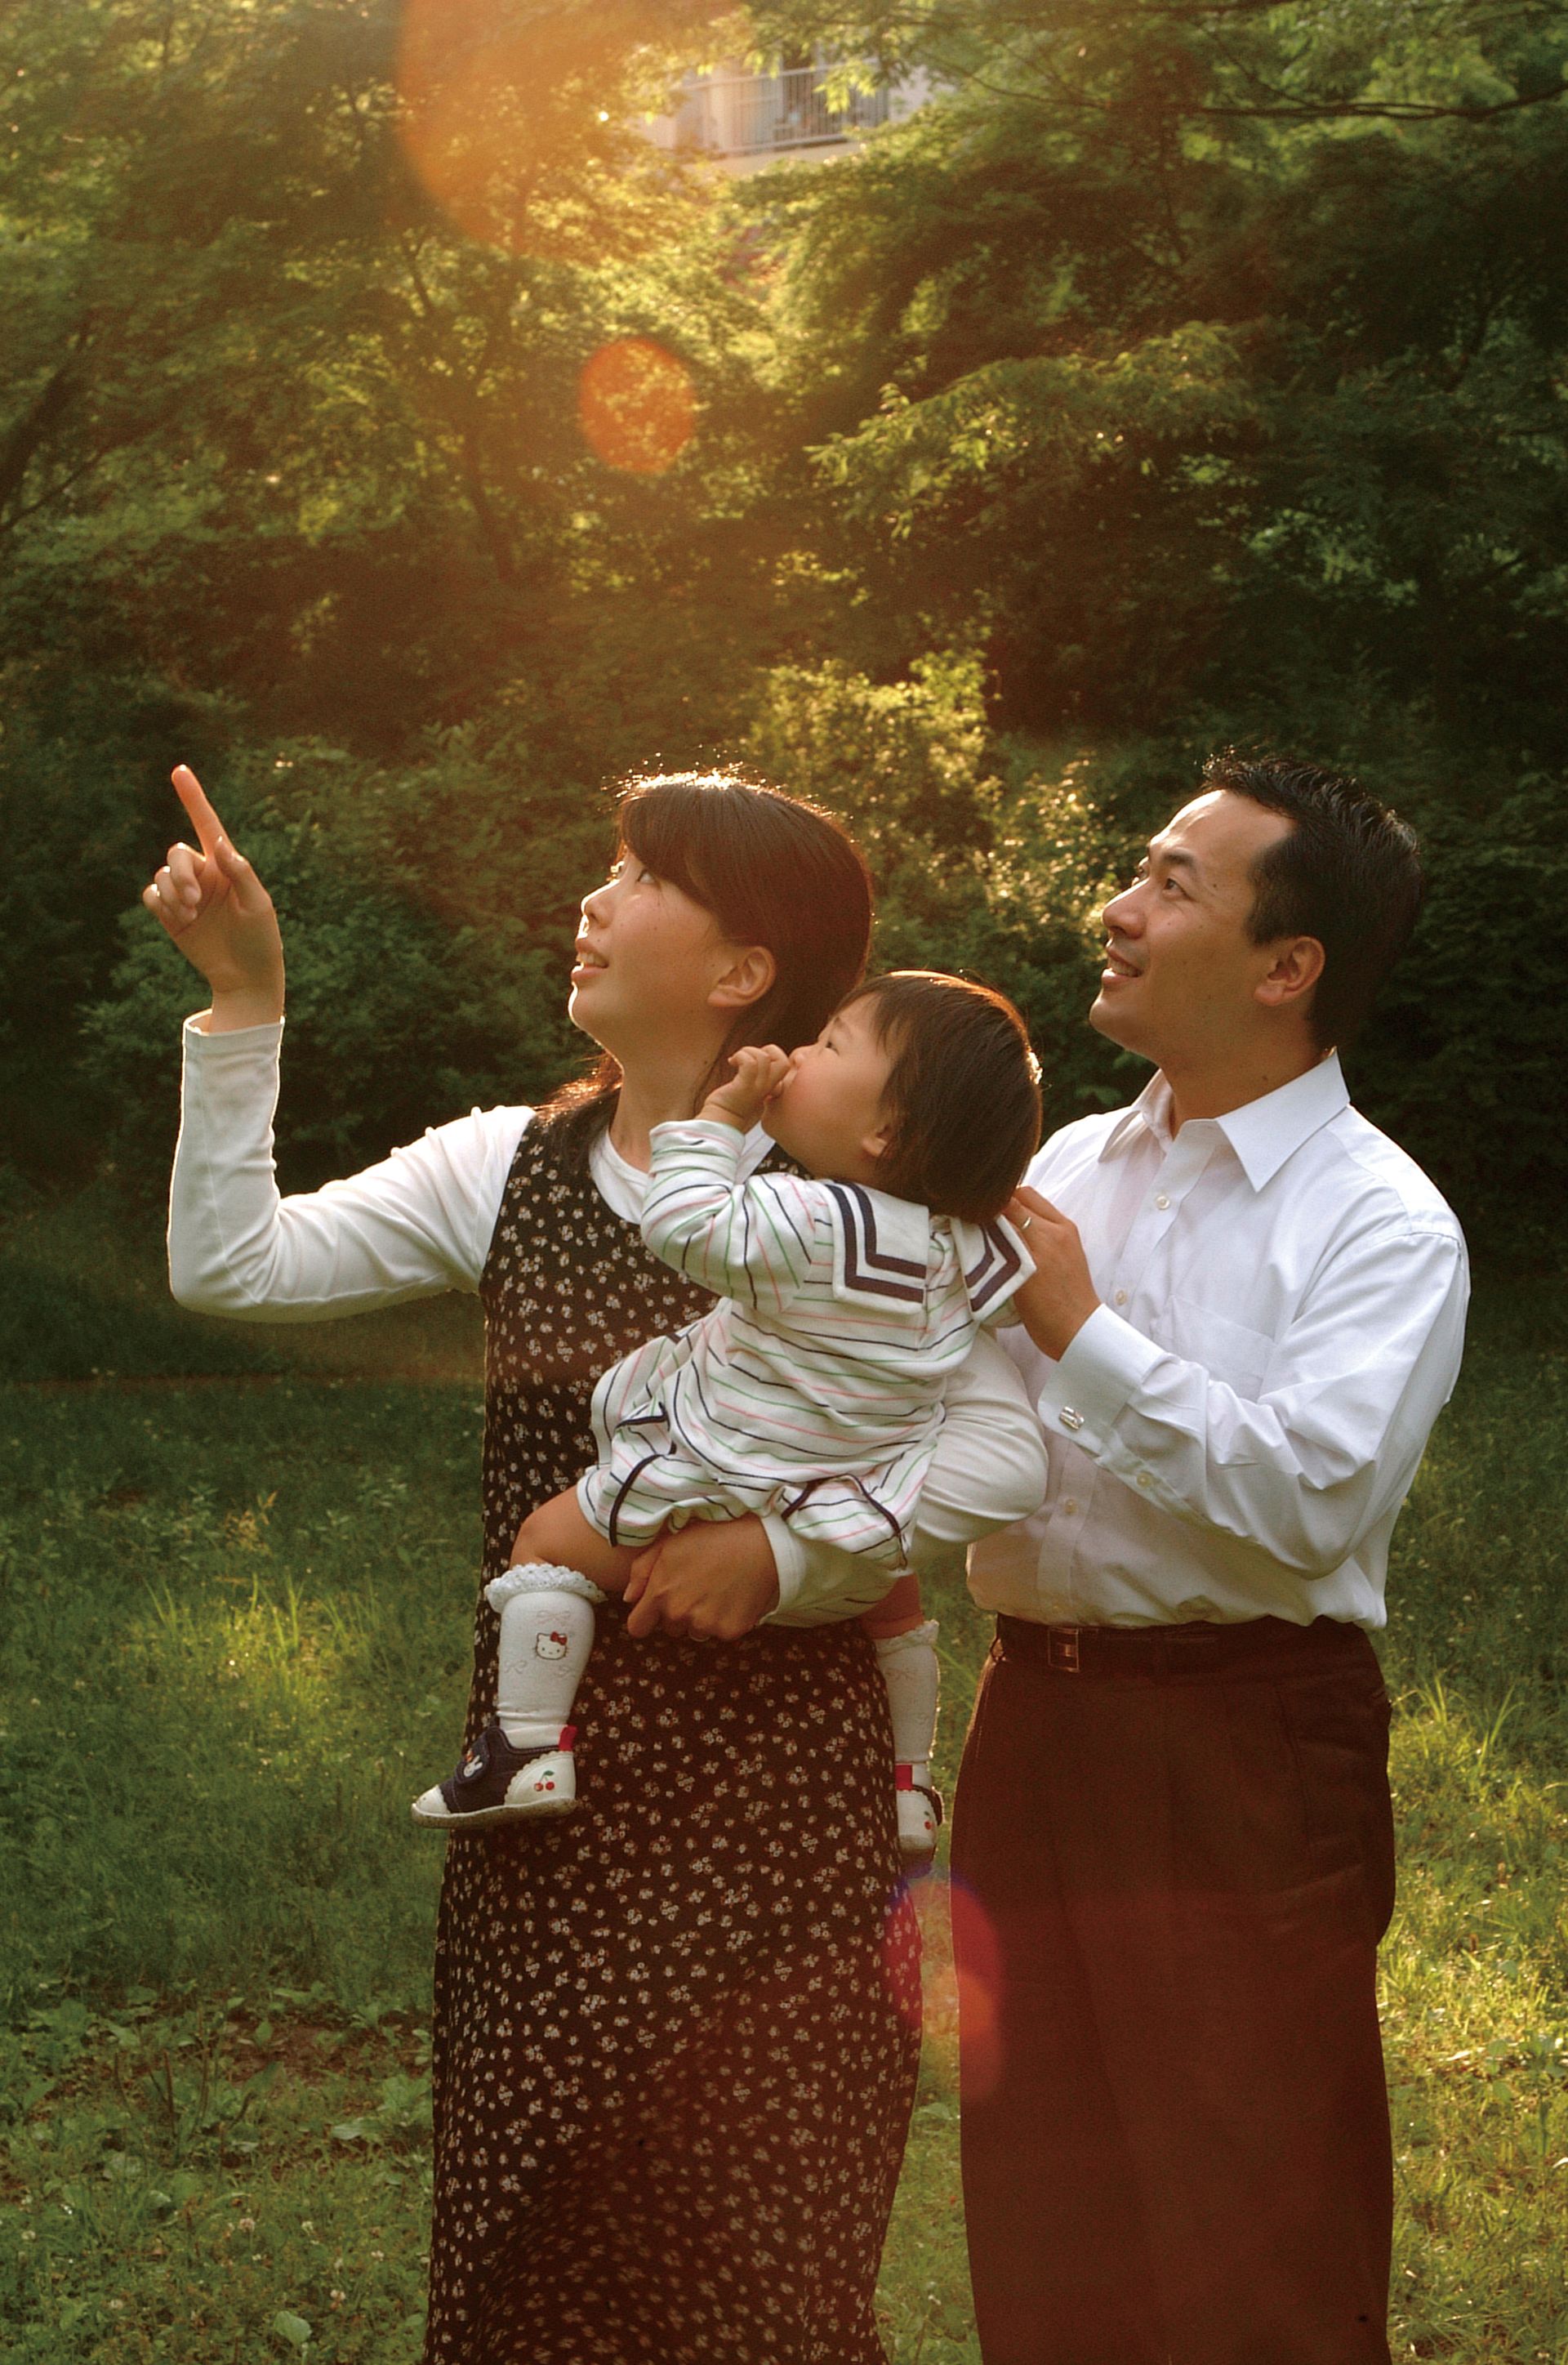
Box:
xmin=580 ymin=1118 xmax=1034 ymax=1568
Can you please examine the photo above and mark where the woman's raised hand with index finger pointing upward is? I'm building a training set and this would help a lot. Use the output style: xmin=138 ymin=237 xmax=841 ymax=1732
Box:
xmin=142 ymin=764 xmax=284 ymax=1033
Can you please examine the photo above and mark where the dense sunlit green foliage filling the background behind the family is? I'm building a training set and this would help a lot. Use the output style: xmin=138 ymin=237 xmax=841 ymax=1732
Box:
xmin=0 ymin=0 xmax=1568 ymax=1242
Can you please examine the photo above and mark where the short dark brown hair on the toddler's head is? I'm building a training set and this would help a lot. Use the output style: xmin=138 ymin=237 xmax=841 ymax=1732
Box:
xmin=840 ymin=970 xmax=1040 ymax=1223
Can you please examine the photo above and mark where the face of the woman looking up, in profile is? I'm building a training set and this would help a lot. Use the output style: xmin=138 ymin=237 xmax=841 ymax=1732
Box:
xmin=568 ymin=849 xmax=740 ymax=1064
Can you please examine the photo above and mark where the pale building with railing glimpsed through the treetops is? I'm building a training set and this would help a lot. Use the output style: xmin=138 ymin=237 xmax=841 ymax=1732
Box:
xmin=648 ymin=59 xmax=927 ymax=172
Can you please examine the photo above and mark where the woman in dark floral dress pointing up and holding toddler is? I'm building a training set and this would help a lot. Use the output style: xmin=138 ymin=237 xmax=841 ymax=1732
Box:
xmin=145 ymin=769 xmax=1043 ymax=2365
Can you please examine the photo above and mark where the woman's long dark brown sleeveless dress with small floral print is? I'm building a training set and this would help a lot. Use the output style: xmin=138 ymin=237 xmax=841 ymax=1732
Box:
xmin=425 ymin=1126 xmax=920 ymax=2365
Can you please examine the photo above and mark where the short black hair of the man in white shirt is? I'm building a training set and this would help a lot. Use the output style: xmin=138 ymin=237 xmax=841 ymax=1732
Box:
xmin=1204 ymin=747 xmax=1423 ymax=1050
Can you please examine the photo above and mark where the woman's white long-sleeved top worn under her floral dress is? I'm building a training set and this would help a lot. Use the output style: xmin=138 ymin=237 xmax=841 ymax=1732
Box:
xmin=168 ymin=1020 xmax=1045 ymax=1625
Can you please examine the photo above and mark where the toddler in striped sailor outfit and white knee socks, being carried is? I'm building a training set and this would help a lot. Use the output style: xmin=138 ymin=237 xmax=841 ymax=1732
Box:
xmin=414 ymin=970 xmax=1040 ymax=1861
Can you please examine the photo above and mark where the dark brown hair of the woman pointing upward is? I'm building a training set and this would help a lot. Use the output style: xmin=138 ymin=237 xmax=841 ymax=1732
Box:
xmin=539 ymin=771 xmax=871 ymax=1154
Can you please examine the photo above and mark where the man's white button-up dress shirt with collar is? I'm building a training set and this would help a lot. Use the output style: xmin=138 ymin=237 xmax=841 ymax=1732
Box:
xmin=969 ymin=1057 xmax=1468 ymax=1627
